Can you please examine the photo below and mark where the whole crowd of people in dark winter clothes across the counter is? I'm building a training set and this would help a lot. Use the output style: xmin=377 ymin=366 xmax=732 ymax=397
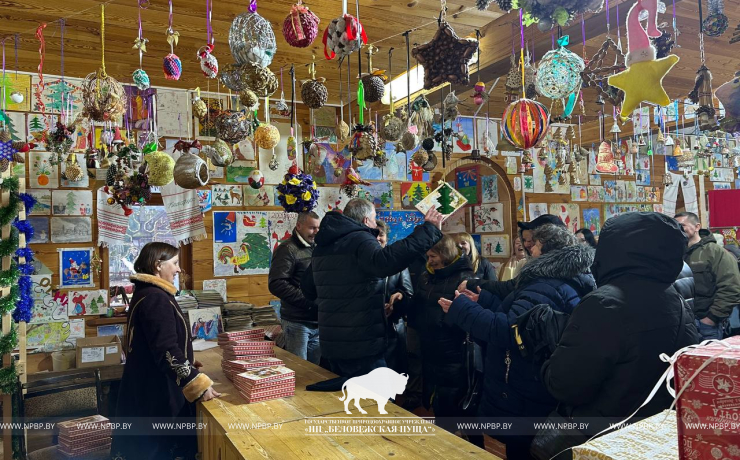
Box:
xmin=269 ymin=202 xmax=740 ymax=460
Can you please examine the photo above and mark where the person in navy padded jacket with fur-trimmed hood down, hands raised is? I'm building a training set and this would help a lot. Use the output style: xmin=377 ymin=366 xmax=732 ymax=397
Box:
xmin=439 ymin=224 xmax=596 ymax=460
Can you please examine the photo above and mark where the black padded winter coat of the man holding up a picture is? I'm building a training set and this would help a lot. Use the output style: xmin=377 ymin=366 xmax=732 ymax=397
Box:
xmin=301 ymin=211 xmax=442 ymax=359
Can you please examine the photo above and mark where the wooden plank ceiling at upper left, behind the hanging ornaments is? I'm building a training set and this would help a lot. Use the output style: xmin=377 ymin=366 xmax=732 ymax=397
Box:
xmin=0 ymin=0 xmax=503 ymax=103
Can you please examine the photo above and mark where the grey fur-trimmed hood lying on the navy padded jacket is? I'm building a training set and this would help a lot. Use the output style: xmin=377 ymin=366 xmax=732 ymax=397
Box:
xmin=517 ymin=244 xmax=595 ymax=286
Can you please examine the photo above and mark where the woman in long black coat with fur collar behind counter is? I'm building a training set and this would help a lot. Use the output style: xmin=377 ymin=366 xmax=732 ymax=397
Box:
xmin=111 ymin=243 xmax=220 ymax=460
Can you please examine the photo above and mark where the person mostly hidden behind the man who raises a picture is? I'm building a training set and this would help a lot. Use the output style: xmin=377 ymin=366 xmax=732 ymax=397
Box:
xmin=375 ymin=220 xmax=414 ymax=374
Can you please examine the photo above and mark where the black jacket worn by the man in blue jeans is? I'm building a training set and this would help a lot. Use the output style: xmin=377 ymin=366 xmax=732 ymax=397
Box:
xmin=268 ymin=229 xmax=319 ymax=327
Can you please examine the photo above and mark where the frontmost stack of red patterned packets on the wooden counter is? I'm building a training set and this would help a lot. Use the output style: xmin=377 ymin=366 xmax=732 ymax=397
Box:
xmin=234 ymin=366 xmax=295 ymax=403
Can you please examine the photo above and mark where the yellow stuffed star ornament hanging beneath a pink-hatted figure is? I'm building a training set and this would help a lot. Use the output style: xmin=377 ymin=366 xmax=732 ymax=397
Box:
xmin=608 ymin=54 xmax=678 ymax=121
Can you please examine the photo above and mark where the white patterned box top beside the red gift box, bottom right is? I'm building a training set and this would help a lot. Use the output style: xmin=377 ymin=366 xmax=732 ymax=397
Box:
xmin=573 ymin=410 xmax=678 ymax=460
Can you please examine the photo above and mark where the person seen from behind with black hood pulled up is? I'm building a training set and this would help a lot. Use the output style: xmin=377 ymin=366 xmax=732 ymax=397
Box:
xmin=535 ymin=212 xmax=699 ymax=459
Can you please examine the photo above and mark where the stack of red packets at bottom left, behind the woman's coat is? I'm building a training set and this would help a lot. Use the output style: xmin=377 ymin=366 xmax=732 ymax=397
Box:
xmin=57 ymin=415 xmax=112 ymax=458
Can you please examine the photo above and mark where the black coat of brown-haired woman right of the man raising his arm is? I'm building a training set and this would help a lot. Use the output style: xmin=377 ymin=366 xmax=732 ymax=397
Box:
xmin=412 ymin=256 xmax=474 ymax=415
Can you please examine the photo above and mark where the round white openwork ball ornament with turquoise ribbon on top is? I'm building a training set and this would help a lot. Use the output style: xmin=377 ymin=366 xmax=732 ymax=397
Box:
xmin=535 ymin=35 xmax=586 ymax=99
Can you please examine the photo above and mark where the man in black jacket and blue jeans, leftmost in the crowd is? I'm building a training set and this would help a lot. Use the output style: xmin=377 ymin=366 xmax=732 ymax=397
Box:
xmin=268 ymin=212 xmax=321 ymax=364
